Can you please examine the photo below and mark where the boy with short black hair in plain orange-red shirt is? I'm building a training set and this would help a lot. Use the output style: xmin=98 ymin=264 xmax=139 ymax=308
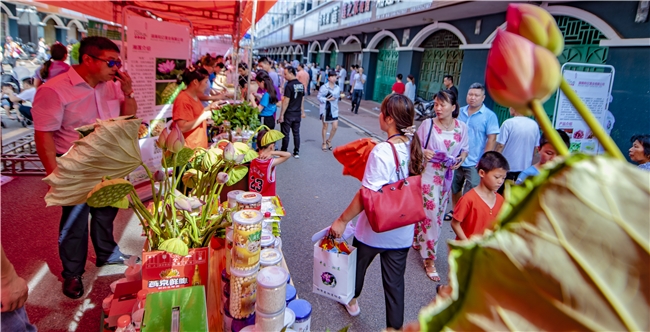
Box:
xmin=451 ymin=151 xmax=510 ymax=240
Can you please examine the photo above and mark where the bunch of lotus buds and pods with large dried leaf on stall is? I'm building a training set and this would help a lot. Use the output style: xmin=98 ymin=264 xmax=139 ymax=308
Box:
xmin=45 ymin=117 xmax=257 ymax=255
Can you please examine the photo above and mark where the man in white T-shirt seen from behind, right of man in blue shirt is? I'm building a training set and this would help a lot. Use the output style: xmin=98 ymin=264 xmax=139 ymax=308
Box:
xmin=495 ymin=107 xmax=540 ymax=194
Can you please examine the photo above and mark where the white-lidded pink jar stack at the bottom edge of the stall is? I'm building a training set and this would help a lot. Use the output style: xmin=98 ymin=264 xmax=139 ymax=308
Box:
xmin=255 ymin=266 xmax=289 ymax=331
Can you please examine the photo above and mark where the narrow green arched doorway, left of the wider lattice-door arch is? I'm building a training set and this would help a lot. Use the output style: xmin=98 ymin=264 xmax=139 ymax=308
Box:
xmin=372 ymin=36 xmax=399 ymax=102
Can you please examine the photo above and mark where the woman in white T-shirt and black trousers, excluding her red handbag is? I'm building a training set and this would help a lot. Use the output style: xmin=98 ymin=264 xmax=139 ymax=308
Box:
xmin=330 ymin=94 xmax=424 ymax=330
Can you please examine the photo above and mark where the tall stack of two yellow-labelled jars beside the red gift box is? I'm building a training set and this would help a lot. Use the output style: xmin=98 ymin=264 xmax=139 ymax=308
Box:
xmin=229 ymin=210 xmax=262 ymax=319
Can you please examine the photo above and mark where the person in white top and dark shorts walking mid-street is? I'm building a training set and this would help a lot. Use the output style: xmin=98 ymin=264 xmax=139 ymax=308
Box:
xmin=318 ymin=70 xmax=341 ymax=151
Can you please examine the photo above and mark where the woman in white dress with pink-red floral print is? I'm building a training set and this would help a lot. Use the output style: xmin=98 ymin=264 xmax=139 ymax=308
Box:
xmin=413 ymin=90 xmax=469 ymax=281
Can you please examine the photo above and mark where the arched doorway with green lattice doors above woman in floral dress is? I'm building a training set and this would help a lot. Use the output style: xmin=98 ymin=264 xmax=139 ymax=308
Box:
xmin=416 ymin=30 xmax=463 ymax=100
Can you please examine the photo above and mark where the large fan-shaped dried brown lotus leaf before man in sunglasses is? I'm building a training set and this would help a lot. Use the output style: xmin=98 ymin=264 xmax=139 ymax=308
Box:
xmin=43 ymin=118 xmax=142 ymax=206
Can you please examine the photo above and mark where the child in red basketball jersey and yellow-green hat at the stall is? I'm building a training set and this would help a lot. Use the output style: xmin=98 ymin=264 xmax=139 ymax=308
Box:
xmin=248 ymin=128 xmax=291 ymax=196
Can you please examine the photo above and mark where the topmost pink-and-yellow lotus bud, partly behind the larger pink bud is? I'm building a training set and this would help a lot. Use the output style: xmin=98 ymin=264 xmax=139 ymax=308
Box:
xmin=506 ymin=3 xmax=564 ymax=55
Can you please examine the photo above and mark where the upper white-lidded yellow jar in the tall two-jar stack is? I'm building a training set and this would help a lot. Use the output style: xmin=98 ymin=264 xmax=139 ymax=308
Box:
xmin=231 ymin=210 xmax=262 ymax=274
